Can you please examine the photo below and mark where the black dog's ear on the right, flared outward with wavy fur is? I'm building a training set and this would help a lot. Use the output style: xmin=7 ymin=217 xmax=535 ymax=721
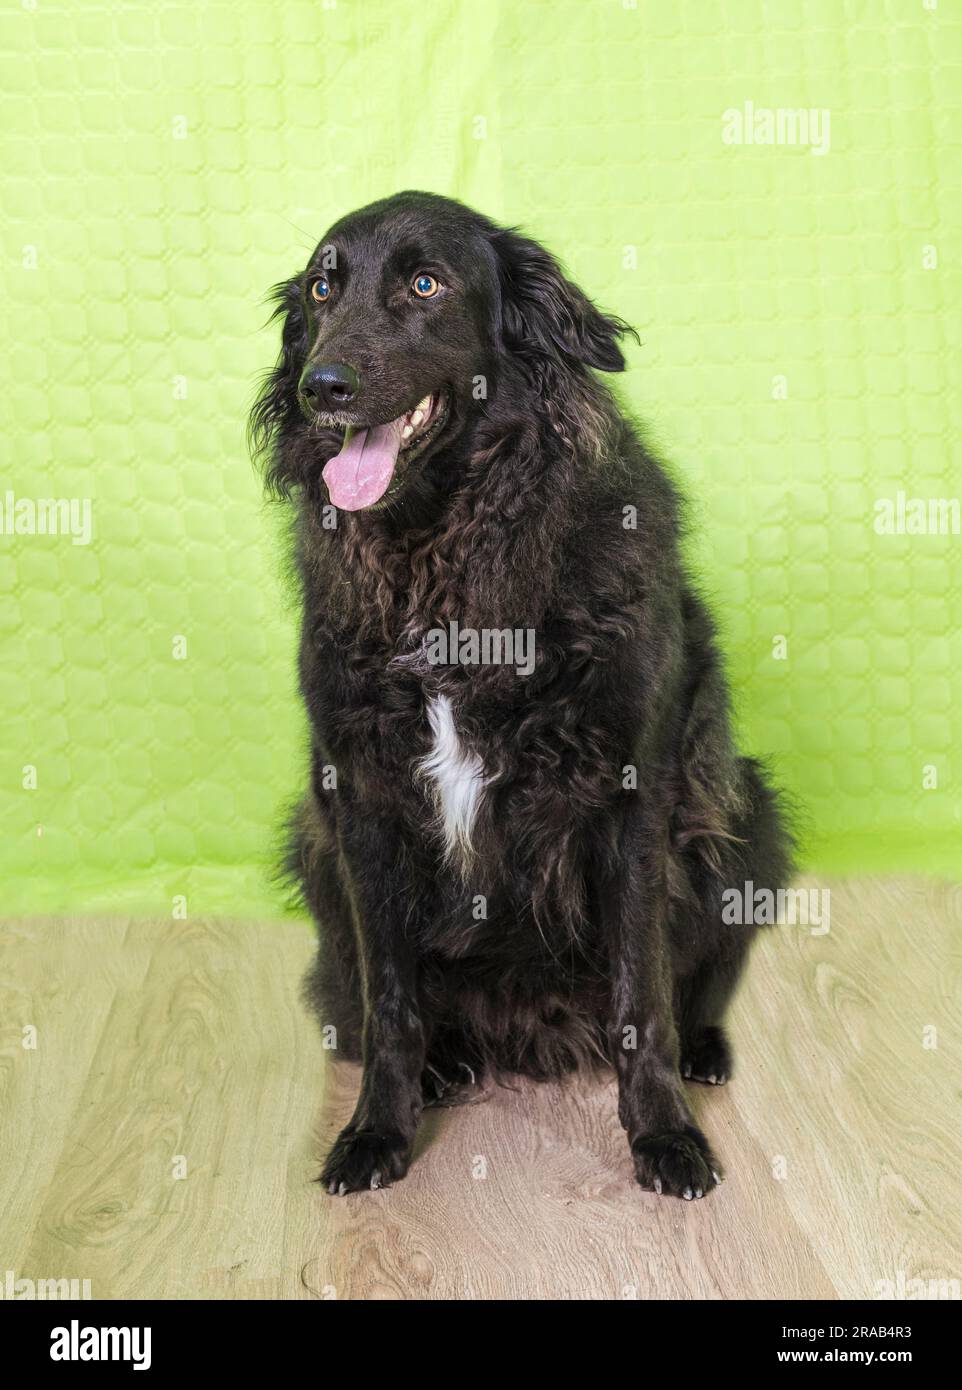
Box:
xmin=491 ymin=228 xmax=638 ymax=371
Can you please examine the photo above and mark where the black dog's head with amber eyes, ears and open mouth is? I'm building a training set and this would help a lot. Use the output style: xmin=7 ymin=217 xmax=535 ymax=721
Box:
xmin=252 ymin=192 xmax=628 ymax=512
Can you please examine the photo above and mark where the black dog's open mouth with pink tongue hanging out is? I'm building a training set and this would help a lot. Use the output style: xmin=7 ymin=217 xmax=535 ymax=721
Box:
xmin=323 ymin=392 xmax=448 ymax=512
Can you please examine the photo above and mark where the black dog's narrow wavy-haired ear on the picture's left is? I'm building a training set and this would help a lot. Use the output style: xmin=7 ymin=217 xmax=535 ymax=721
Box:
xmin=247 ymin=277 xmax=307 ymax=495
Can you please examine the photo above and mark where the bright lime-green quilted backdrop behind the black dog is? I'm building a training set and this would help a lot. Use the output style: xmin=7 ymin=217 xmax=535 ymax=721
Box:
xmin=0 ymin=0 xmax=962 ymax=915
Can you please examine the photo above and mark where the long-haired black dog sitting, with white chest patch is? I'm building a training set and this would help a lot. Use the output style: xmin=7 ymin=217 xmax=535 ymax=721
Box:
xmin=252 ymin=193 xmax=791 ymax=1198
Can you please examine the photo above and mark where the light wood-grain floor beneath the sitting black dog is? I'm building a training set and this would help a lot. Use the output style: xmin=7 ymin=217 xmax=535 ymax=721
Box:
xmin=0 ymin=880 xmax=962 ymax=1298
